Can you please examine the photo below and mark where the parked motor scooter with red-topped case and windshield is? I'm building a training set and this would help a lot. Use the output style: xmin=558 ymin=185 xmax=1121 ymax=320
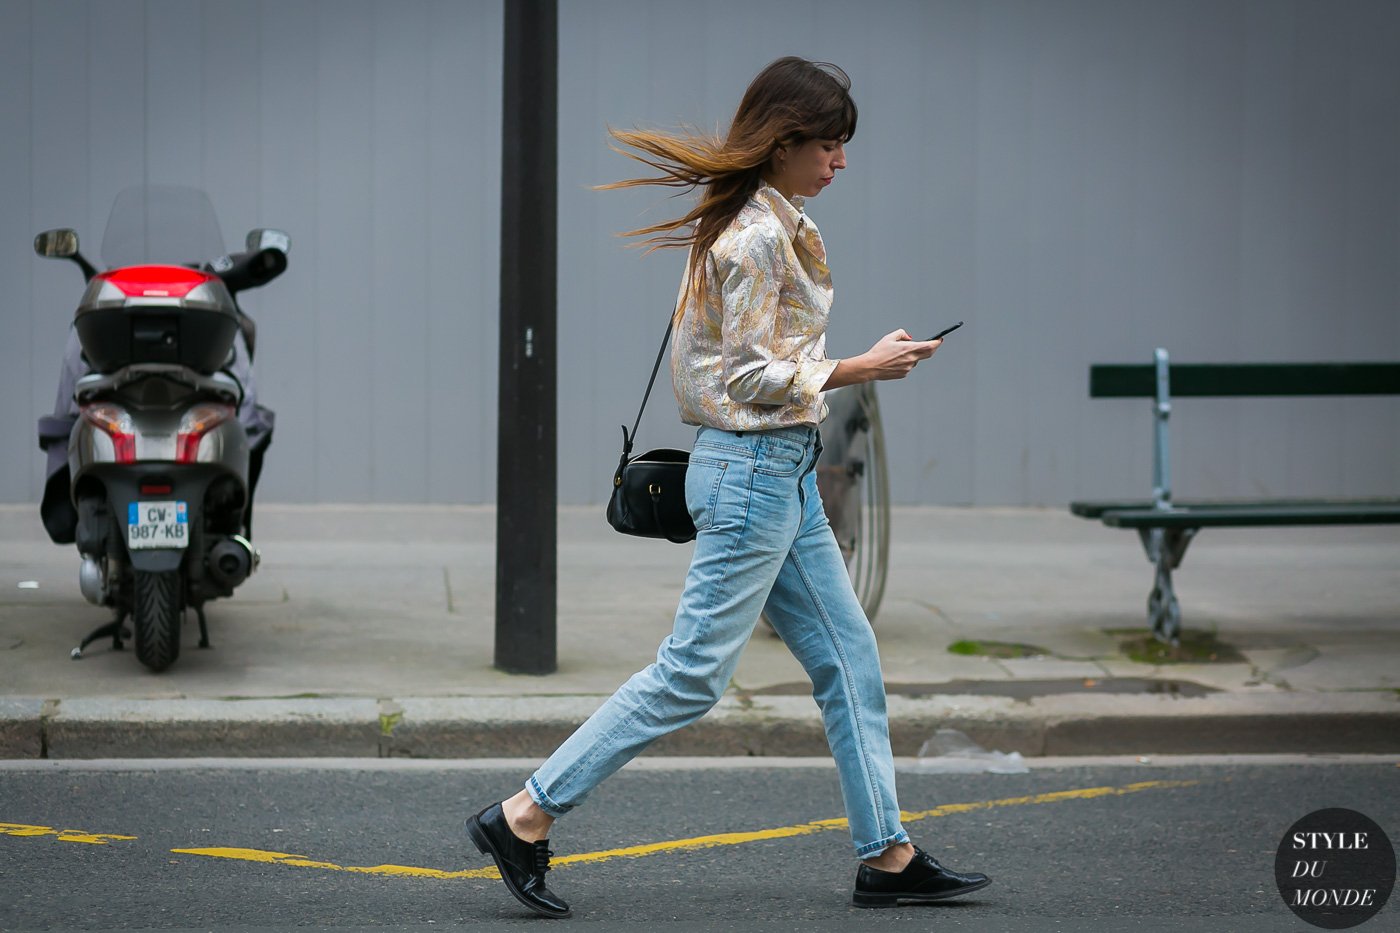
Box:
xmin=34 ymin=186 xmax=291 ymax=671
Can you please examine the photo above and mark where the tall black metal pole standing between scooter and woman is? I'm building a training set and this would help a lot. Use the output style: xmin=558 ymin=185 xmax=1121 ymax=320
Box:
xmin=496 ymin=0 xmax=559 ymax=674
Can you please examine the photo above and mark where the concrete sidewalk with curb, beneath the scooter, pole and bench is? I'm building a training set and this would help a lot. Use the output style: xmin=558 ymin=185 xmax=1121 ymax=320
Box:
xmin=0 ymin=506 xmax=1400 ymax=758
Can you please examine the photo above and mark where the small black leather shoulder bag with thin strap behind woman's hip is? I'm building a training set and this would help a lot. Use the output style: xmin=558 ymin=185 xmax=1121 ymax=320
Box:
xmin=608 ymin=311 xmax=696 ymax=544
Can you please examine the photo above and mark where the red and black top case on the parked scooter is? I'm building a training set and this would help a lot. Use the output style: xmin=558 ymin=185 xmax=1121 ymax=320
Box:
xmin=73 ymin=265 xmax=238 ymax=374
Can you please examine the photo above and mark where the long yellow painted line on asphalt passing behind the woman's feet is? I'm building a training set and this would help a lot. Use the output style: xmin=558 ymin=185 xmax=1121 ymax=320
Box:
xmin=171 ymin=780 xmax=1200 ymax=878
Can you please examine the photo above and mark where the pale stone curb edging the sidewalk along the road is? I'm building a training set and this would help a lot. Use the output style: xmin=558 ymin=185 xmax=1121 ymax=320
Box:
xmin=0 ymin=692 xmax=1400 ymax=759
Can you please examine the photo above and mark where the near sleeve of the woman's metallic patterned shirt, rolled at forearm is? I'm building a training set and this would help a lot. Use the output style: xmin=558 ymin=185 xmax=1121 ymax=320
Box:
xmin=717 ymin=224 xmax=837 ymax=408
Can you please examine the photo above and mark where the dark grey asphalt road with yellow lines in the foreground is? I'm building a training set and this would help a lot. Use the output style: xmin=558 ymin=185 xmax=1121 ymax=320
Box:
xmin=0 ymin=759 xmax=1400 ymax=933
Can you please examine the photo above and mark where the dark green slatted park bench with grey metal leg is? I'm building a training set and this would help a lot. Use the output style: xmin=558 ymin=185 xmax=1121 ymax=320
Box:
xmin=1070 ymin=349 xmax=1400 ymax=644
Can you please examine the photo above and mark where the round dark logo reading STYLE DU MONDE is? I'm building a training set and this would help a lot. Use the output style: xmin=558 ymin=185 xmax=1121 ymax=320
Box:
xmin=1274 ymin=807 xmax=1396 ymax=930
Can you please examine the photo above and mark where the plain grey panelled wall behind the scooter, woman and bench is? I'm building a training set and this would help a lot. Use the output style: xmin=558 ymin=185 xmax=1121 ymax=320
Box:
xmin=0 ymin=0 xmax=1400 ymax=504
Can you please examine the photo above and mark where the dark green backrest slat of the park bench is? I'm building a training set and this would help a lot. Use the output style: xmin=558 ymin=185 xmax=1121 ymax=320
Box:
xmin=1089 ymin=363 xmax=1400 ymax=398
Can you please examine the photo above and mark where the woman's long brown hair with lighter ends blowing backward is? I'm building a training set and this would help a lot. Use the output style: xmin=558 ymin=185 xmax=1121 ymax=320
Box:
xmin=598 ymin=56 xmax=857 ymax=311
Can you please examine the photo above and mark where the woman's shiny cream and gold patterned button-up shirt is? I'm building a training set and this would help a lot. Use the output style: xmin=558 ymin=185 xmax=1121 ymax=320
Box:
xmin=671 ymin=185 xmax=837 ymax=431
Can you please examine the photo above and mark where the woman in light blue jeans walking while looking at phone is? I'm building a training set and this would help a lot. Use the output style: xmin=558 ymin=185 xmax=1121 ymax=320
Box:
xmin=466 ymin=57 xmax=990 ymax=916
